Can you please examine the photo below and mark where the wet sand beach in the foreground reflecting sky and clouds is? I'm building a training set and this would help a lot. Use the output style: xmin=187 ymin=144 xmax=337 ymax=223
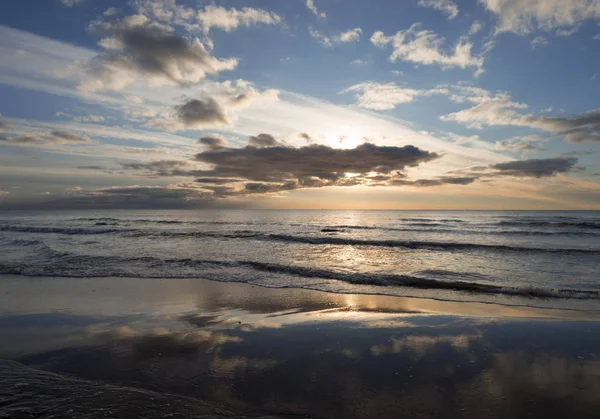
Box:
xmin=0 ymin=276 xmax=600 ymax=419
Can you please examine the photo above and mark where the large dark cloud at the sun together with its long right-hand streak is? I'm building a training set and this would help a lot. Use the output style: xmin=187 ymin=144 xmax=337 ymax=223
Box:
xmin=113 ymin=134 xmax=577 ymax=198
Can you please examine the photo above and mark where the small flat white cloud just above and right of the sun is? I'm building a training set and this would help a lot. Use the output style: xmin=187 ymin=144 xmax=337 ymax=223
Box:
xmin=340 ymin=82 xmax=448 ymax=110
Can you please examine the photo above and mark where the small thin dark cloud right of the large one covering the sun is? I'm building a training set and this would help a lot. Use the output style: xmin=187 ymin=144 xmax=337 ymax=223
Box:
xmin=490 ymin=157 xmax=577 ymax=178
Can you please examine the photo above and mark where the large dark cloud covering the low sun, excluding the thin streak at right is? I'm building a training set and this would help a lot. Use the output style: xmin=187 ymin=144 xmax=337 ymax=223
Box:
xmin=123 ymin=137 xmax=440 ymax=198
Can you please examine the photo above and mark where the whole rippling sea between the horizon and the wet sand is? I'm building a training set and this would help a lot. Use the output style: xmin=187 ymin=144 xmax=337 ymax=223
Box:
xmin=0 ymin=210 xmax=600 ymax=310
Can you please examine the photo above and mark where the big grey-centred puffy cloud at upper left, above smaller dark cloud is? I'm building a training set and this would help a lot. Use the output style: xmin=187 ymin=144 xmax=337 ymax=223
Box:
xmin=80 ymin=15 xmax=238 ymax=91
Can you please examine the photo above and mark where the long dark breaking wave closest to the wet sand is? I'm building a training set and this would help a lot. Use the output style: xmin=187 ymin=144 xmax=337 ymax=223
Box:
xmin=0 ymin=255 xmax=600 ymax=299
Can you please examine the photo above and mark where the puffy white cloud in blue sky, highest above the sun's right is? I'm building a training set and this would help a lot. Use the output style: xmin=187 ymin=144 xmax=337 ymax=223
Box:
xmin=371 ymin=23 xmax=484 ymax=75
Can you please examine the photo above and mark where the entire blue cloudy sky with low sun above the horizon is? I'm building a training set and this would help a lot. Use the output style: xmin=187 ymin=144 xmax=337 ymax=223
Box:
xmin=0 ymin=0 xmax=600 ymax=209
